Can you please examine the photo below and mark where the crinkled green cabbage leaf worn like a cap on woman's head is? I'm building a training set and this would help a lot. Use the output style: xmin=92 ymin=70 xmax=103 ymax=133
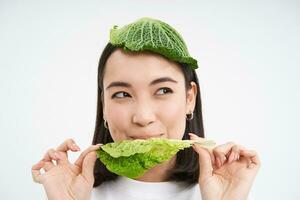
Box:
xmin=109 ymin=17 xmax=198 ymax=69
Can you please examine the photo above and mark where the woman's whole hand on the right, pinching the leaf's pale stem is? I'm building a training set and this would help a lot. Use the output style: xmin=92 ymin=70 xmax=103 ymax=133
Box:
xmin=190 ymin=134 xmax=260 ymax=200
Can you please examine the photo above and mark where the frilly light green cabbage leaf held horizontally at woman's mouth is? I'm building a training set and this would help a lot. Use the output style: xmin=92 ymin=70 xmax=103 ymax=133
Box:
xmin=96 ymin=138 xmax=215 ymax=178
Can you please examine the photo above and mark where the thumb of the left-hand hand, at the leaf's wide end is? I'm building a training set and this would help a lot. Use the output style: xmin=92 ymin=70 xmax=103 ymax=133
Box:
xmin=82 ymin=151 xmax=97 ymax=183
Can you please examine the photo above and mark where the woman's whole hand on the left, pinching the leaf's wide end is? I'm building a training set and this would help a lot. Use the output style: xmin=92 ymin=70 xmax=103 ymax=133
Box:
xmin=31 ymin=139 xmax=100 ymax=200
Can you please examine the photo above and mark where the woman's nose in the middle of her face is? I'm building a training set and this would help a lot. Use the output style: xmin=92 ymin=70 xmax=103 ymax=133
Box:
xmin=132 ymin=101 xmax=156 ymax=127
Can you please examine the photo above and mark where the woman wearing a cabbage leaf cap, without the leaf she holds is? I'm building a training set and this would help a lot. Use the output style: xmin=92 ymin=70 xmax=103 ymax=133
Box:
xmin=32 ymin=18 xmax=260 ymax=200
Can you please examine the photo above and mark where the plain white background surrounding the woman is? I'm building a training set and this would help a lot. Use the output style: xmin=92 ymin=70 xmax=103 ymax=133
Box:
xmin=0 ymin=0 xmax=300 ymax=199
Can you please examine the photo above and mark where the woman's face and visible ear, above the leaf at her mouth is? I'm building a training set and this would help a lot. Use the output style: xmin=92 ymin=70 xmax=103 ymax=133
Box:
xmin=103 ymin=49 xmax=197 ymax=141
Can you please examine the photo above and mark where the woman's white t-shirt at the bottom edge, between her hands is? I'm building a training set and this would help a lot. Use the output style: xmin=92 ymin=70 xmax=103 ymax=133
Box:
xmin=91 ymin=176 xmax=201 ymax=200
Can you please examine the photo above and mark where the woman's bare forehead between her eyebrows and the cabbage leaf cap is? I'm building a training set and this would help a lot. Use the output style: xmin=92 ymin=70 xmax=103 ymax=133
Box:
xmin=103 ymin=49 xmax=184 ymax=85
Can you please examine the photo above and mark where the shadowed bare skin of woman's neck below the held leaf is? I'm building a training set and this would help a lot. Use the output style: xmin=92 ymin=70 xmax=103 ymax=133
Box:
xmin=136 ymin=156 xmax=176 ymax=182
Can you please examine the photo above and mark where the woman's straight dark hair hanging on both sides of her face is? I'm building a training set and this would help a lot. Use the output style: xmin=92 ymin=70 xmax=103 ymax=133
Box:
xmin=92 ymin=43 xmax=204 ymax=187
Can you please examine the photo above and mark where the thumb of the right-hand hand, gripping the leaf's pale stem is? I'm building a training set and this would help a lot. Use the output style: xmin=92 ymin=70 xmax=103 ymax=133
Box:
xmin=190 ymin=134 xmax=214 ymax=179
